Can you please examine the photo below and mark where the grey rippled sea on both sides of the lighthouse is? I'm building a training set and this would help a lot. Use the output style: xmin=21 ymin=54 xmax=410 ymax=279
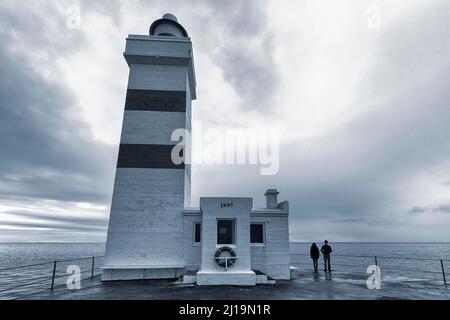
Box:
xmin=0 ymin=242 xmax=450 ymax=299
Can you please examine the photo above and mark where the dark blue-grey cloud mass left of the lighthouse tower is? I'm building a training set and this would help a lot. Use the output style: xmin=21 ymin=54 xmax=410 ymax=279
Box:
xmin=0 ymin=2 xmax=117 ymax=240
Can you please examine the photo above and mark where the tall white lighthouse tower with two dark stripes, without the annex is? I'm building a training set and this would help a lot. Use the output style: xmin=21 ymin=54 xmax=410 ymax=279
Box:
xmin=103 ymin=14 xmax=196 ymax=280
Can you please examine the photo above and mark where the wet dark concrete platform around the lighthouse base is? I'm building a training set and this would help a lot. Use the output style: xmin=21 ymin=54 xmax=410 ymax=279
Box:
xmin=23 ymin=271 xmax=450 ymax=300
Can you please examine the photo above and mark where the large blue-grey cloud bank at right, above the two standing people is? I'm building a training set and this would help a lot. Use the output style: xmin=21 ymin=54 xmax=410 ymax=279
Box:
xmin=196 ymin=2 xmax=450 ymax=237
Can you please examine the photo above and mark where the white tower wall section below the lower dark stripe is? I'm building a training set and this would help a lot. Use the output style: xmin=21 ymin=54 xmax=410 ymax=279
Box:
xmin=104 ymin=168 xmax=184 ymax=268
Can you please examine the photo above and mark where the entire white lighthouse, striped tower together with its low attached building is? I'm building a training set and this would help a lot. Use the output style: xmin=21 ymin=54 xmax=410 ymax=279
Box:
xmin=103 ymin=14 xmax=290 ymax=285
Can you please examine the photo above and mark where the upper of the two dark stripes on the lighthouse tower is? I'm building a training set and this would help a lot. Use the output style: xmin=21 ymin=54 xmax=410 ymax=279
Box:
xmin=125 ymin=89 xmax=186 ymax=112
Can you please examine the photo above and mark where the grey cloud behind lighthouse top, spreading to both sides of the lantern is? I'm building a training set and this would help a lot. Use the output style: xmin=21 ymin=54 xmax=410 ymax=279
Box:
xmin=80 ymin=0 xmax=279 ymax=111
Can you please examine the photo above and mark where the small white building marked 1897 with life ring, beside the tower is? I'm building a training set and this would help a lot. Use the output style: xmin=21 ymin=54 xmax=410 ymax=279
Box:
xmin=184 ymin=190 xmax=290 ymax=285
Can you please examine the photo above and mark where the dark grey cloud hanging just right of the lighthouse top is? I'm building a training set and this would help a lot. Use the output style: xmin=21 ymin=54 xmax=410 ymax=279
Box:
xmin=191 ymin=0 xmax=279 ymax=111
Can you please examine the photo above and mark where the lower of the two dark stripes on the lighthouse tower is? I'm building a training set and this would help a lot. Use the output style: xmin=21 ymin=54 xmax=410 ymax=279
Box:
xmin=117 ymin=144 xmax=184 ymax=169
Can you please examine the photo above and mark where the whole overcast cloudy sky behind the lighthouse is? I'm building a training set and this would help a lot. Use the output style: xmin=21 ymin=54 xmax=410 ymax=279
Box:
xmin=0 ymin=0 xmax=450 ymax=241
